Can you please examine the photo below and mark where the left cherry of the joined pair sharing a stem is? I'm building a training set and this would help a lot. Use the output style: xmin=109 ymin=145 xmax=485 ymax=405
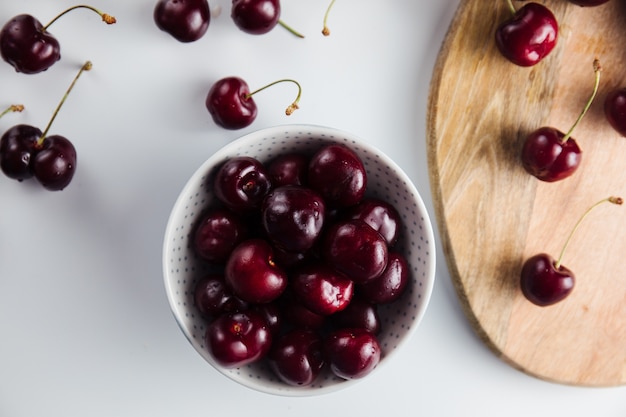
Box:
xmin=0 ymin=124 xmax=42 ymax=181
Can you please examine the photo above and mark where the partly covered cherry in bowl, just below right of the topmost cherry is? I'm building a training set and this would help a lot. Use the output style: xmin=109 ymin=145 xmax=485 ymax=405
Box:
xmin=350 ymin=198 xmax=402 ymax=246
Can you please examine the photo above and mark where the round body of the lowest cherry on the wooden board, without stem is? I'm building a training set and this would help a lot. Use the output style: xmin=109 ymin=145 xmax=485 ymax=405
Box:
xmin=520 ymin=253 xmax=576 ymax=307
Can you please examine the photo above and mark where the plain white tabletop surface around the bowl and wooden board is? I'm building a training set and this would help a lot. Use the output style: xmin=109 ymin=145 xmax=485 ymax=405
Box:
xmin=0 ymin=0 xmax=626 ymax=417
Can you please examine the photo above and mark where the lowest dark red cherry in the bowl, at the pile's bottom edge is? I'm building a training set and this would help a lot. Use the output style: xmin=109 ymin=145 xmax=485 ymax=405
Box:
xmin=268 ymin=329 xmax=325 ymax=386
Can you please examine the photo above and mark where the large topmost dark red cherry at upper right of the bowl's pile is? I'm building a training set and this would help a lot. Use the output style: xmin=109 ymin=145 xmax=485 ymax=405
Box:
xmin=307 ymin=144 xmax=367 ymax=207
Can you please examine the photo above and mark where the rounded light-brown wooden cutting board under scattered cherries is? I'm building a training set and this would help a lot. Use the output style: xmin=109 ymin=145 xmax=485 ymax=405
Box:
xmin=427 ymin=0 xmax=626 ymax=386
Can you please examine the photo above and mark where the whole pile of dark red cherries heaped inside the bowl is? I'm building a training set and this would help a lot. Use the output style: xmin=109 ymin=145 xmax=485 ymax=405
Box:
xmin=189 ymin=144 xmax=410 ymax=386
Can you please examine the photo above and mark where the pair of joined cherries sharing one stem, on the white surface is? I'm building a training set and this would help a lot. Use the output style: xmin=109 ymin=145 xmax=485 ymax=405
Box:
xmin=0 ymin=61 xmax=92 ymax=191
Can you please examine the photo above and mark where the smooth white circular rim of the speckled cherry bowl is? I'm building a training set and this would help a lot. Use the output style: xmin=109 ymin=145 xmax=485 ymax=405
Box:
xmin=162 ymin=124 xmax=437 ymax=397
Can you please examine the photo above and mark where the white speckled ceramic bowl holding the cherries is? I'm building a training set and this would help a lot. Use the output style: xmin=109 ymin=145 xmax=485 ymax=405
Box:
xmin=163 ymin=125 xmax=435 ymax=396
